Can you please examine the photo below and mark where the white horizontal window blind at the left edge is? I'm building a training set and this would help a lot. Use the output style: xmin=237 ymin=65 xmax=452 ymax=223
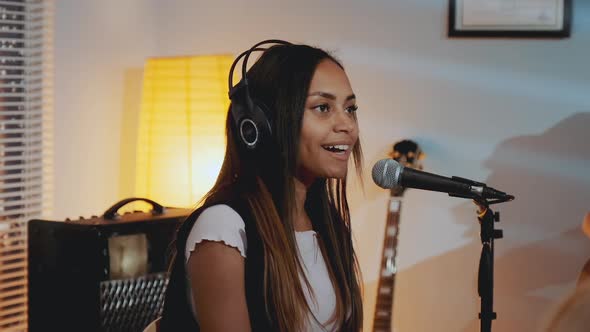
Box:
xmin=0 ymin=0 xmax=53 ymax=331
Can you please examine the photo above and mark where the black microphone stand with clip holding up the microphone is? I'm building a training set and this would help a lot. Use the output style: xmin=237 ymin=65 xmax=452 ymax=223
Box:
xmin=449 ymin=176 xmax=514 ymax=332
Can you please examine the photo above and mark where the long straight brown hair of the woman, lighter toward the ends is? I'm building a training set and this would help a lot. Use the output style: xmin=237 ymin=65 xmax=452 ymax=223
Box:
xmin=202 ymin=45 xmax=363 ymax=332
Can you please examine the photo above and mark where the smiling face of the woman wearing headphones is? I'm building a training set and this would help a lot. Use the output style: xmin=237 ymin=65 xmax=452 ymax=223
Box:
xmin=297 ymin=60 xmax=359 ymax=184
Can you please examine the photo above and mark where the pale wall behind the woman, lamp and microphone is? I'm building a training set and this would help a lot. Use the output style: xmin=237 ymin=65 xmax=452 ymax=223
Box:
xmin=55 ymin=0 xmax=590 ymax=332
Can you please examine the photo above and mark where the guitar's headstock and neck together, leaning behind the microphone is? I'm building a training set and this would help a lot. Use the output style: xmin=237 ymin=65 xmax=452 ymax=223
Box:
xmin=373 ymin=140 xmax=424 ymax=332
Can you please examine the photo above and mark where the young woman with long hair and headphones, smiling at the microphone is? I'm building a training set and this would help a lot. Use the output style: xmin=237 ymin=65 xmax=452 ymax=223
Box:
xmin=160 ymin=40 xmax=363 ymax=332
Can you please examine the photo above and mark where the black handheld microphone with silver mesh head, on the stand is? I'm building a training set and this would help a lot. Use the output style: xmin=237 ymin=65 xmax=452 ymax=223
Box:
xmin=373 ymin=159 xmax=514 ymax=201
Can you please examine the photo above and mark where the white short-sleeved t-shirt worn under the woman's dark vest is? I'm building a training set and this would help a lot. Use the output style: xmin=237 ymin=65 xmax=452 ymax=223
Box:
xmin=184 ymin=204 xmax=336 ymax=332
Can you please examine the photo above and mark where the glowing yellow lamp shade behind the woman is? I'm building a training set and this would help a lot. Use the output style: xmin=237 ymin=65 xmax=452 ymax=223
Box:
xmin=135 ymin=55 xmax=233 ymax=207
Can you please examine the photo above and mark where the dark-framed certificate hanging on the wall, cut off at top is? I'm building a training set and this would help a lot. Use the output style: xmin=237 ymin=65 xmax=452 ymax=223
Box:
xmin=448 ymin=0 xmax=572 ymax=38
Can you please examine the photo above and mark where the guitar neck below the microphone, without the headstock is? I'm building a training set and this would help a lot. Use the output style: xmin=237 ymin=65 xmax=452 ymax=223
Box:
xmin=373 ymin=196 xmax=401 ymax=332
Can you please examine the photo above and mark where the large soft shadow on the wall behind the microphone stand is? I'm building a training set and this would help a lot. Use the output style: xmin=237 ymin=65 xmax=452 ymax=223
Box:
xmin=394 ymin=113 xmax=590 ymax=332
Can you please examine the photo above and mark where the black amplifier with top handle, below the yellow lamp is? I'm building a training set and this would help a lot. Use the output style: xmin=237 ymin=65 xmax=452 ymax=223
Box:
xmin=28 ymin=198 xmax=192 ymax=332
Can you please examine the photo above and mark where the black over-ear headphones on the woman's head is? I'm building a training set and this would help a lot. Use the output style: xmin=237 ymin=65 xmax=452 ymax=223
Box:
xmin=228 ymin=39 xmax=292 ymax=150
